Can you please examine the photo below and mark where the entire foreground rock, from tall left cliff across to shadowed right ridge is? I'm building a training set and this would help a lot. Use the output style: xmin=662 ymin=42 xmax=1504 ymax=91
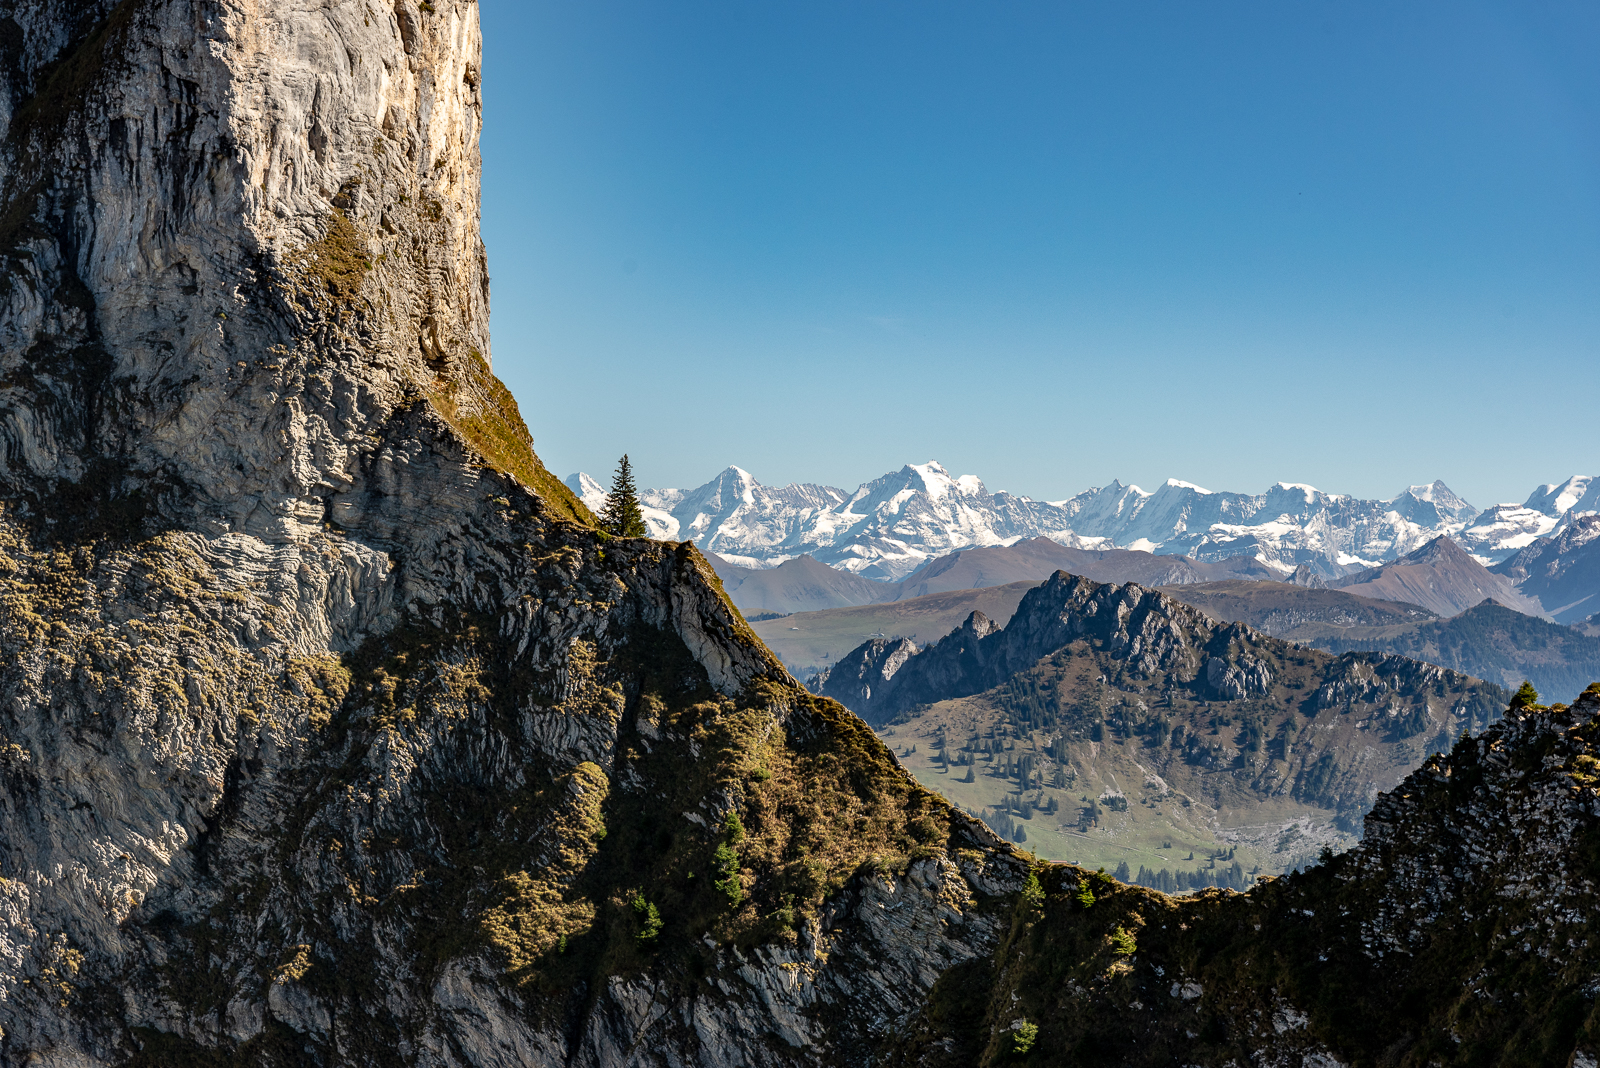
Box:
xmin=9 ymin=0 xmax=1600 ymax=1068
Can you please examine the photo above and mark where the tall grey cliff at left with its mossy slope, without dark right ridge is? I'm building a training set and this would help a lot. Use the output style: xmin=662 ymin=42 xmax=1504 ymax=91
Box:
xmin=0 ymin=0 xmax=1024 ymax=1065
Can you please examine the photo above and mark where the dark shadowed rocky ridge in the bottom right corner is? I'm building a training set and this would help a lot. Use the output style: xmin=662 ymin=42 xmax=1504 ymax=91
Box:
xmin=890 ymin=686 xmax=1600 ymax=1068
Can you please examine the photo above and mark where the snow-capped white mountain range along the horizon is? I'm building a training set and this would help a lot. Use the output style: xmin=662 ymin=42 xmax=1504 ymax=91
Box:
xmin=566 ymin=460 xmax=1600 ymax=580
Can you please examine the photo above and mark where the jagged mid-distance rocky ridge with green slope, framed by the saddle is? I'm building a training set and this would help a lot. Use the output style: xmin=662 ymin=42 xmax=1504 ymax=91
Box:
xmin=813 ymin=572 xmax=1510 ymax=871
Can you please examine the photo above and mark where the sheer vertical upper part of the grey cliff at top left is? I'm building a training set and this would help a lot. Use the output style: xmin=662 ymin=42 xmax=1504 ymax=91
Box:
xmin=0 ymin=0 xmax=490 ymax=539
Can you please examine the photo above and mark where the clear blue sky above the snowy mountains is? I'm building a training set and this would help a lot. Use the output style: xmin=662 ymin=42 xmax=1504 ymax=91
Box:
xmin=480 ymin=0 xmax=1600 ymax=507
